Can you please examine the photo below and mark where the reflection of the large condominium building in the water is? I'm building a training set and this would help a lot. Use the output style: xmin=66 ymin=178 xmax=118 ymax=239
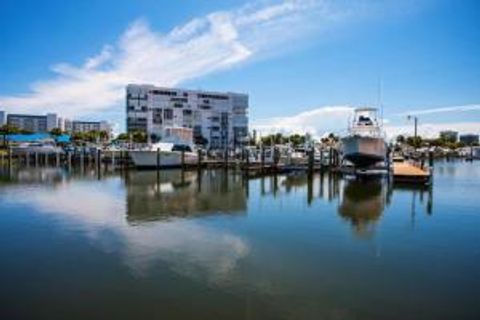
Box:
xmin=125 ymin=170 xmax=247 ymax=222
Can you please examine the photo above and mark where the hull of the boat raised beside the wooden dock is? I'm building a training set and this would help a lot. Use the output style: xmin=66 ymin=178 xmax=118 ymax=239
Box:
xmin=342 ymin=136 xmax=387 ymax=168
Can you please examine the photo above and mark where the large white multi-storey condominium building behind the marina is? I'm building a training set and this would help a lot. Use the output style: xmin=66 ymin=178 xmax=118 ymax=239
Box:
xmin=126 ymin=84 xmax=248 ymax=149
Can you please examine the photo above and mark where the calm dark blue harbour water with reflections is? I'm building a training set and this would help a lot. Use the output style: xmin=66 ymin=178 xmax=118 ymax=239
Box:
xmin=0 ymin=162 xmax=480 ymax=319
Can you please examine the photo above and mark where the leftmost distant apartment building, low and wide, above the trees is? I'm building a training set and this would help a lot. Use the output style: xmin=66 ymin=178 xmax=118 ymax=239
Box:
xmin=7 ymin=113 xmax=57 ymax=132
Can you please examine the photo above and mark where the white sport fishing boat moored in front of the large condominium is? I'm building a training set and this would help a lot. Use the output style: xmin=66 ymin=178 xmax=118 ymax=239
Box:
xmin=130 ymin=127 xmax=198 ymax=168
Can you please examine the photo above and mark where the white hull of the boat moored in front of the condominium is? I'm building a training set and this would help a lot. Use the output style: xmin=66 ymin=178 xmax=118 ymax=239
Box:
xmin=130 ymin=150 xmax=198 ymax=168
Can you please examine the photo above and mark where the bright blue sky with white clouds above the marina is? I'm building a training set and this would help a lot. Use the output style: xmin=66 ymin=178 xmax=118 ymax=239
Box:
xmin=0 ymin=0 xmax=480 ymax=136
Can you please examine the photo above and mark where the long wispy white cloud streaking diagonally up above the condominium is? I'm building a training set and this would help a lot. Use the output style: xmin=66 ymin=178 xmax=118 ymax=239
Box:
xmin=0 ymin=0 xmax=352 ymax=117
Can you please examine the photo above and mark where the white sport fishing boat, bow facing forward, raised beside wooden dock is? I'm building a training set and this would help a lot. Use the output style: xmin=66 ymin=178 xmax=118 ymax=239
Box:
xmin=341 ymin=108 xmax=387 ymax=168
